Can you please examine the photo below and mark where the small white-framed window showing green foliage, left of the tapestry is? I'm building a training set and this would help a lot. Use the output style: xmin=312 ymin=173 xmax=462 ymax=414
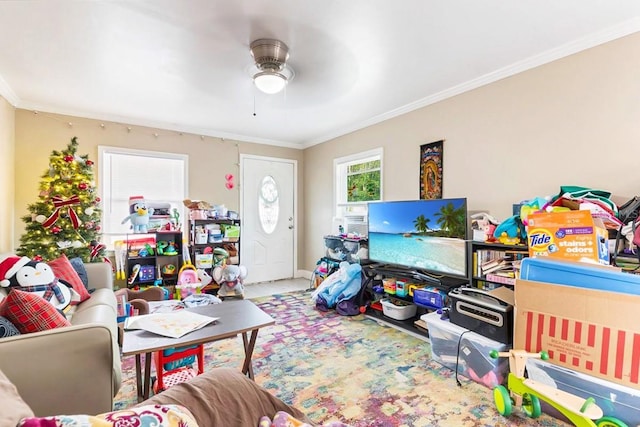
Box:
xmin=333 ymin=148 xmax=382 ymax=226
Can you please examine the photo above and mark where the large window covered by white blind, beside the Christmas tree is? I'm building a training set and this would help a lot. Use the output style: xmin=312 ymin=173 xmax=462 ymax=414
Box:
xmin=98 ymin=146 xmax=188 ymax=248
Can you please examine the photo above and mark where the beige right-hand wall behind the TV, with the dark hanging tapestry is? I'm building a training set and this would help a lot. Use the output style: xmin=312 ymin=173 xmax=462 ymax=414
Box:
xmin=301 ymin=33 xmax=640 ymax=269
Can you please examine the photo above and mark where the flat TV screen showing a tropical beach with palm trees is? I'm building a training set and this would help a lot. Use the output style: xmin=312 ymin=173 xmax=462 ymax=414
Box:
xmin=369 ymin=198 xmax=467 ymax=277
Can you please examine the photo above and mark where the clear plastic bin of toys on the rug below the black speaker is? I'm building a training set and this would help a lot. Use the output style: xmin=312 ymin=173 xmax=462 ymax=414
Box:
xmin=420 ymin=312 xmax=511 ymax=389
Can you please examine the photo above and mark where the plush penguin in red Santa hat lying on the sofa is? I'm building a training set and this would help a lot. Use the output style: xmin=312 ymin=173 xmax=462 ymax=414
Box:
xmin=0 ymin=256 xmax=72 ymax=310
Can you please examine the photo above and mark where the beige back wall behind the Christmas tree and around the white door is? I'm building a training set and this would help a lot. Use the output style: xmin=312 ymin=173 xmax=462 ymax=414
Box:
xmin=13 ymin=109 xmax=304 ymax=266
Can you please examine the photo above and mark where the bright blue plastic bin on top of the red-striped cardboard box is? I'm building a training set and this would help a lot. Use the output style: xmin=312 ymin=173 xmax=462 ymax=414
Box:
xmin=520 ymin=258 xmax=640 ymax=295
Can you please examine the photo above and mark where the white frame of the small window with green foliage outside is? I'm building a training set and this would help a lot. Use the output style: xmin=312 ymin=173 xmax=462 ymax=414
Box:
xmin=333 ymin=147 xmax=384 ymax=220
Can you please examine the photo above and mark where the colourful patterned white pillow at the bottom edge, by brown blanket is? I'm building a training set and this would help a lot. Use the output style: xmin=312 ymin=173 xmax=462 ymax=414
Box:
xmin=17 ymin=402 xmax=198 ymax=427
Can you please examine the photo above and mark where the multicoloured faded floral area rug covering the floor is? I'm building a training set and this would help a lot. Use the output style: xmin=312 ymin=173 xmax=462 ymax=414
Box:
xmin=115 ymin=291 xmax=566 ymax=427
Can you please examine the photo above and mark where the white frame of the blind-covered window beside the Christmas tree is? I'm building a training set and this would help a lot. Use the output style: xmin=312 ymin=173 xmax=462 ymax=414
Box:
xmin=98 ymin=145 xmax=189 ymax=249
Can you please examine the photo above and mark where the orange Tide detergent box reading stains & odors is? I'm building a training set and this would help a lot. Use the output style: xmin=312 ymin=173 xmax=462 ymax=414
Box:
xmin=527 ymin=210 xmax=609 ymax=265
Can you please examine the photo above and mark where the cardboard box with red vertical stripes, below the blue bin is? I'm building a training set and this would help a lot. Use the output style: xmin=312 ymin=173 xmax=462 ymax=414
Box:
xmin=514 ymin=280 xmax=640 ymax=389
